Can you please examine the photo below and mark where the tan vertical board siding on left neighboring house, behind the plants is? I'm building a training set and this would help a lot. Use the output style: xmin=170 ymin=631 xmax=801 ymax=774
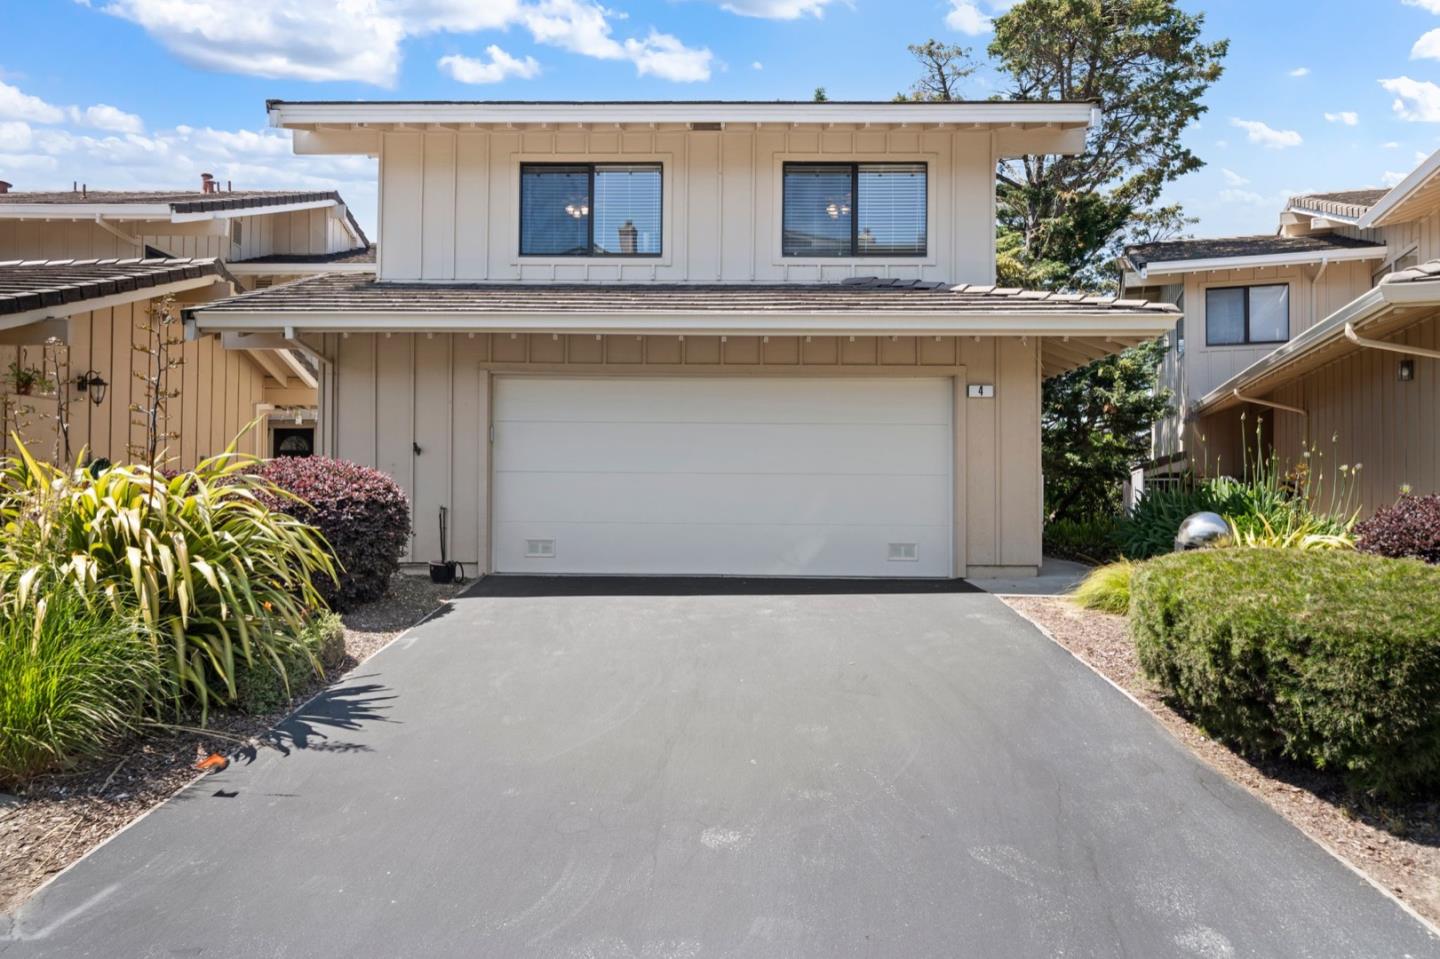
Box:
xmin=0 ymin=301 xmax=265 ymax=468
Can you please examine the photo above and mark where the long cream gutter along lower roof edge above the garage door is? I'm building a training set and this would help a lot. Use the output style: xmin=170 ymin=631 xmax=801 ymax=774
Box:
xmin=189 ymin=307 xmax=1181 ymax=338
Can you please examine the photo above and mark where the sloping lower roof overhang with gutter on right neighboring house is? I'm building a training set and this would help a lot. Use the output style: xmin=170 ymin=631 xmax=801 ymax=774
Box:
xmin=1192 ymin=275 xmax=1440 ymax=416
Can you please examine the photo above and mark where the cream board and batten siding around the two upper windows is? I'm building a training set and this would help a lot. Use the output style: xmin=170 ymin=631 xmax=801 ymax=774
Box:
xmin=379 ymin=130 xmax=995 ymax=284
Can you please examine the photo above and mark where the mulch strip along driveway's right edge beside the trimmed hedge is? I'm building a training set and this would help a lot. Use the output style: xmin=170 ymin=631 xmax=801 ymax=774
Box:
xmin=1005 ymin=596 xmax=1440 ymax=923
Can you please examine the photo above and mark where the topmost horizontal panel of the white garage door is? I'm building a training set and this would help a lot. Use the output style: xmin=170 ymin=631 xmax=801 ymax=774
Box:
xmin=495 ymin=376 xmax=950 ymax=425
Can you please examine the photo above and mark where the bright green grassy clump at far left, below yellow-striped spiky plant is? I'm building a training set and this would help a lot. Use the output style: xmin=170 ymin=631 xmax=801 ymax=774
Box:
xmin=0 ymin=592 xmax=160 ymax=786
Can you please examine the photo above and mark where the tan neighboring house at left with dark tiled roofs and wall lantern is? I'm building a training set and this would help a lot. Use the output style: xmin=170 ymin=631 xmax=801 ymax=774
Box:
xmin=0 ymin=181 xmax=374 ymax=467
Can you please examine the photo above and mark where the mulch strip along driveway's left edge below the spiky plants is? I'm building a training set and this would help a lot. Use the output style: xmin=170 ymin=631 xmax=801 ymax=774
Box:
xmin=0 ymin=575 xmax=461 ymax=914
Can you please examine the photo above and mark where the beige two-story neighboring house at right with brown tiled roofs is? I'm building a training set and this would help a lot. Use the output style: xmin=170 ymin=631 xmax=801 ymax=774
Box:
xmin=1122 ymin=154 xmax=1440 ymax=511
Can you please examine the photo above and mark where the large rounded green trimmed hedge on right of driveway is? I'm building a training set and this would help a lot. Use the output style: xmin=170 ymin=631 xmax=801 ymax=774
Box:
xmin=1130 ymin=549 xmax=1440 ymax=798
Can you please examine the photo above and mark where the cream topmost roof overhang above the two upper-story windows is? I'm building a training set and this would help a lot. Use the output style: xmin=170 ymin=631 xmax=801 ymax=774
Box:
xmin=268 ymin=101 xmax=1100 ymax=157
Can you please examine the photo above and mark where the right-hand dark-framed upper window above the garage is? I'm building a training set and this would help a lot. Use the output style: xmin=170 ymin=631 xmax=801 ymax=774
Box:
xmin=780 ymin=163 xmax=927 ymax=256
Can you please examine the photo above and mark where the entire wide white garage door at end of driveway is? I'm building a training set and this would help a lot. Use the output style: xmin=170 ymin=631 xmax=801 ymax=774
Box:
xmin=492 ymin=376 xmax=953 ymax=576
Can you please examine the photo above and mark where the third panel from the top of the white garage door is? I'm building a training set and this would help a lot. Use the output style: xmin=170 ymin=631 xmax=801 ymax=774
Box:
xmin=495 ymin=472 xmax=950 ymax=526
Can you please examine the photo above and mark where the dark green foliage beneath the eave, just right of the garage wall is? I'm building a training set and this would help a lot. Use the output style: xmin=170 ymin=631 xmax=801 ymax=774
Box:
xmin=1040 ymin=332 xmax=1171 ymax=520
